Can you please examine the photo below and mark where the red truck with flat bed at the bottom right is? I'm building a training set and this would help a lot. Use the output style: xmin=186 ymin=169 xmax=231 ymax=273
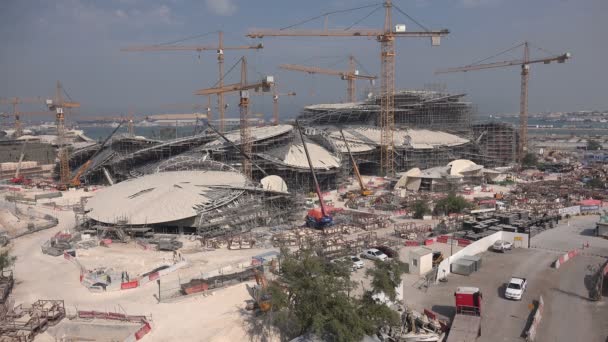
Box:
xmin=446 ymin=286 xmax=483 ymax=342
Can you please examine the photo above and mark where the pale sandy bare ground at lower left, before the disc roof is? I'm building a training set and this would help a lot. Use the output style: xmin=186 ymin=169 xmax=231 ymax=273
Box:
xmin=1 ymin=200 xmax=276 ymax=341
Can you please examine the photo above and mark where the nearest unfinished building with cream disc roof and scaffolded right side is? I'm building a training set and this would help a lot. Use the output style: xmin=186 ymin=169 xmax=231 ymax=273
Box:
xmin=85 ymin=156 xmax=303 ymax=236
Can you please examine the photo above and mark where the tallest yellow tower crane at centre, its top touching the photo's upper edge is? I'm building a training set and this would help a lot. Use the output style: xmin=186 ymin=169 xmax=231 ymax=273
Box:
xmin=247 ymin=0 xmax=449 ymax=176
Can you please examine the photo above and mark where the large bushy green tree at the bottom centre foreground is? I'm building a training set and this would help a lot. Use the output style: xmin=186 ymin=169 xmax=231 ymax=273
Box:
xmin=269 ymin=250 xmax=373 ymax=342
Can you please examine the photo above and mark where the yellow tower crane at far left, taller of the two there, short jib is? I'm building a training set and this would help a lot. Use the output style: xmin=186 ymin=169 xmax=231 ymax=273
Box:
xmin=46 ymin=81 xmax=80 ymax=187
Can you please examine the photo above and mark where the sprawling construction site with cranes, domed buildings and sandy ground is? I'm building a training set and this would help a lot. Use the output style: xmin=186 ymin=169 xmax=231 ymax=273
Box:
xmin=0 ymin=1 xmax=608 ymax=342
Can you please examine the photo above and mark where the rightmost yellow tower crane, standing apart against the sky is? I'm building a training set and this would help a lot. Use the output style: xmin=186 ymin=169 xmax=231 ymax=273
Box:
xmin=435 ymin=41 xmax=572 ymax=163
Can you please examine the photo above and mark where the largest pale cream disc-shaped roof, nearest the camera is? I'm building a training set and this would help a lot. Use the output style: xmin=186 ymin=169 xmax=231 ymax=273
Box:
xmin=86 ymin=171 xmax=247 ymax=225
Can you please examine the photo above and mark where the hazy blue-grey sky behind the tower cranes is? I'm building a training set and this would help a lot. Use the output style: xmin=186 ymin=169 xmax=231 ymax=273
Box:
xmin=0 ymin=0 xmax=608 ymax=121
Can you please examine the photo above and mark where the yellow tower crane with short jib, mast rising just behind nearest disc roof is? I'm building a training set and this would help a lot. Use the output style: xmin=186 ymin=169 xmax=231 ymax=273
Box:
xmin=194 ymin=56 xmax=274 ymax=179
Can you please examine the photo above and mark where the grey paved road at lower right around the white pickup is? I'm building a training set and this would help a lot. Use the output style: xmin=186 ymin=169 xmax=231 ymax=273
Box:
xmin=405 ymin=216 xmax=608 ymax=342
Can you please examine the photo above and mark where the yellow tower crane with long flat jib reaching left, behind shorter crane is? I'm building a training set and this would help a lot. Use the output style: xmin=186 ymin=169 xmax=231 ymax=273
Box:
xmin=120 ymin=31 xmax=264 ymax=132
